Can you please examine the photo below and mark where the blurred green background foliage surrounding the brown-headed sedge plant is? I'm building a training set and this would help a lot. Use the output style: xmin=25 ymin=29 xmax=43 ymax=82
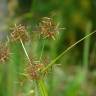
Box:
xmin=0 ymin=0 xmax=96 ymax=96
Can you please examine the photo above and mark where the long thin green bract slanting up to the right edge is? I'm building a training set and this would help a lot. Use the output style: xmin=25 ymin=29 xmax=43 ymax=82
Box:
xmin=42 ymin=31 xmax=96 ymax=72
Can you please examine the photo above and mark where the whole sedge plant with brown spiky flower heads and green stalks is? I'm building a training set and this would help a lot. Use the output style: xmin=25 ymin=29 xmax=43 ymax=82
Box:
xmin=0 ymin=17 xmax=96 ymax=96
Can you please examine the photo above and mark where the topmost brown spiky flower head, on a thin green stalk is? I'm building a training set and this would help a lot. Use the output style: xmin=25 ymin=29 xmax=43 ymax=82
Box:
xmin=39 ymin=17 xmax=58 ymax=40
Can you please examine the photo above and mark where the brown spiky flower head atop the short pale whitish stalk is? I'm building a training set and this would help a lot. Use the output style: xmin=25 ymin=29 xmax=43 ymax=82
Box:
xmin=11 ymin=24 xmax=28 ymax=41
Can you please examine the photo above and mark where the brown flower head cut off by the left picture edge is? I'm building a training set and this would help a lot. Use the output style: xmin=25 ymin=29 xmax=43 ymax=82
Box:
xmin=0 ymin=43 xmax=9 ymax=63
